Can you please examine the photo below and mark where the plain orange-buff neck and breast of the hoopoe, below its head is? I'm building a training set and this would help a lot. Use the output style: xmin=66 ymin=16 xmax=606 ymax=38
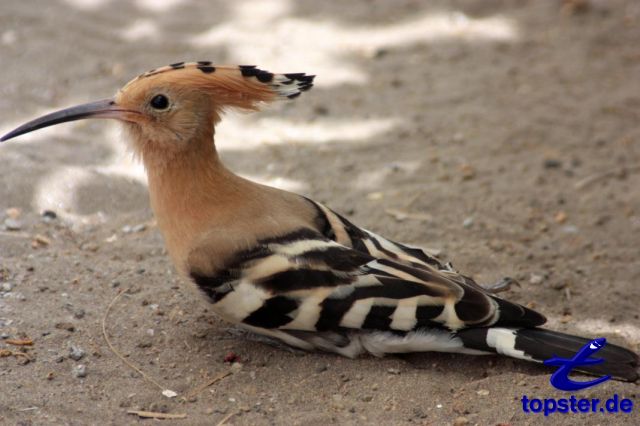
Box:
xmin=142 ymin=136 xmax=316 ymax=274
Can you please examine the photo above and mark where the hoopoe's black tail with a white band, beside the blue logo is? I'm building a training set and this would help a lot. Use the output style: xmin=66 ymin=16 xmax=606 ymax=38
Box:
xmin=456 ymin=327 xmax=640 ymax=382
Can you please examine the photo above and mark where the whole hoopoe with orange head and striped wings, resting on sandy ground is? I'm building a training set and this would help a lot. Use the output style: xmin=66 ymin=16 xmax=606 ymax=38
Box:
xmin=0 ymin=61 xmax=639 ymax=382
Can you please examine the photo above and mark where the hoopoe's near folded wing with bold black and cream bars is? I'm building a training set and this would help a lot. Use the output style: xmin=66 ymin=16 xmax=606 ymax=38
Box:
xmin=192 ymin=228 xmax=545 ymax=338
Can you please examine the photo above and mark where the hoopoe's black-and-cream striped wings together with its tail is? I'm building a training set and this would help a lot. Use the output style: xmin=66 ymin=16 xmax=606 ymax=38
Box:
xmin=192 ymin=200 xmax=638 ymax=381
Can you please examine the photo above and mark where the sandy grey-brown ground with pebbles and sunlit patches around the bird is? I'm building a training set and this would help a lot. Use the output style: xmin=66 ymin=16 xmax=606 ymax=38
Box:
xmin=0 ymin=0 xmax=640 ymax=425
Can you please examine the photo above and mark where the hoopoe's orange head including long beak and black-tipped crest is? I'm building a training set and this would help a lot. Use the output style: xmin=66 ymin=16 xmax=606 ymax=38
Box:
xmin=0 ymin=61 xmax=314 ymax=161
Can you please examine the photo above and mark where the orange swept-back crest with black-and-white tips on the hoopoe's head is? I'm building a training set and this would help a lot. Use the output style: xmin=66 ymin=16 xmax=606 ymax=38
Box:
xmin=121 ymin=61 xmax=315 ymax=110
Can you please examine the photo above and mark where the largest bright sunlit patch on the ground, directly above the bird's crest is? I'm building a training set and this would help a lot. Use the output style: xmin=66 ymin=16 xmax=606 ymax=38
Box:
xmin=191 ymin=0 xmax=519 ymax=87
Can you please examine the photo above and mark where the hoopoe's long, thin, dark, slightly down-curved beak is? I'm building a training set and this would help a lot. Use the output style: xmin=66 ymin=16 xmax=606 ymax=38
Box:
xmin=0 ymin=98 xmax=135 ymax=142
